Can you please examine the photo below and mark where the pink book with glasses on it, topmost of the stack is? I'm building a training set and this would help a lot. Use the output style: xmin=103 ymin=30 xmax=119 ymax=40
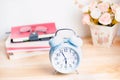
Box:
xmin=10 ymin=23 xmax=56 ymax=42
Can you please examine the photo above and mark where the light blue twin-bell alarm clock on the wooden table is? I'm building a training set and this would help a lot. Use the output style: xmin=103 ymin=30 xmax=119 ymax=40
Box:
xmin=49 ymin=29 xmax=82 ymax=73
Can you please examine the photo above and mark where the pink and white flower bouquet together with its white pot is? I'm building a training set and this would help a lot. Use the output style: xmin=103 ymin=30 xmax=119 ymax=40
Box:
xmin=76 ymin=0 xmax=120 ymax=47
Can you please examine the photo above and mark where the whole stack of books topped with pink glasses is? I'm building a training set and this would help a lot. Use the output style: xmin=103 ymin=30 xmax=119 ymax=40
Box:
xmin=6 ymin=23 xmax=56 ymax=59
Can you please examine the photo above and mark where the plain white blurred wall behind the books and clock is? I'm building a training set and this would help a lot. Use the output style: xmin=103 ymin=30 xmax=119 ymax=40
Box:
xmin=0 ymin=0 xmax=119 ymax=39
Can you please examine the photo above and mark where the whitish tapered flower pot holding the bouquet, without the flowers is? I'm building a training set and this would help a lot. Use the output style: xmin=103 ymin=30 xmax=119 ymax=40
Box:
xmin=89 ymin=23 xmax=119 ymax=47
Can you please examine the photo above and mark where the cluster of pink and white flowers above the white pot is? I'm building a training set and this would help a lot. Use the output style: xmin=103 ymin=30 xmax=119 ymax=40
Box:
xmin=74 ymin=0 xmax=120 ymax=26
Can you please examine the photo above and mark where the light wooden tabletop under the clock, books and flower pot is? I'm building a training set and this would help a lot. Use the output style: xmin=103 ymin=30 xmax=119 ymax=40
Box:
xmin=0 ymin=37 xmax=120 ymax=80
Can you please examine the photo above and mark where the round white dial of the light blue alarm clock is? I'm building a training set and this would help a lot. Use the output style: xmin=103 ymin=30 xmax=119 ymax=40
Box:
xmin=51 ymin=47 xmax=80 ymax=73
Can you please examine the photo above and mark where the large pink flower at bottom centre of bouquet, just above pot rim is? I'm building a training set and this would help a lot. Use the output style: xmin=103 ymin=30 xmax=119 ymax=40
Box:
xmin=99 ymin=12 xmax=112 ymax=25
